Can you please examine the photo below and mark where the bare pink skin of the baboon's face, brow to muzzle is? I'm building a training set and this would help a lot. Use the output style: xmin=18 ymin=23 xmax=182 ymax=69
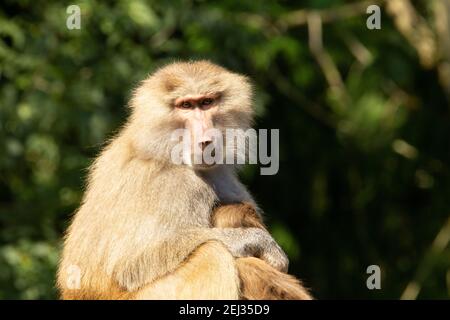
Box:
xmin=175 ymin=95 xmax=219 ymax=150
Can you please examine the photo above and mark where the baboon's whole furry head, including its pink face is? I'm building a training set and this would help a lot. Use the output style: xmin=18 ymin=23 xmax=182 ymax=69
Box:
xmin=130 ymin=61 xmax=253 ymax=169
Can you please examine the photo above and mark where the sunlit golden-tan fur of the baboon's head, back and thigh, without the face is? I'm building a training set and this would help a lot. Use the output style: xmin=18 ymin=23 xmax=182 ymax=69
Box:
xmin=57 ymin=61 xmax=312 ymax=299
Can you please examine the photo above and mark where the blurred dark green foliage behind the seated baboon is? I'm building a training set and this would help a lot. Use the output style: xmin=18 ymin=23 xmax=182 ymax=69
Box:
xmin=0 ymin=0 xmax=450 ymax=299
